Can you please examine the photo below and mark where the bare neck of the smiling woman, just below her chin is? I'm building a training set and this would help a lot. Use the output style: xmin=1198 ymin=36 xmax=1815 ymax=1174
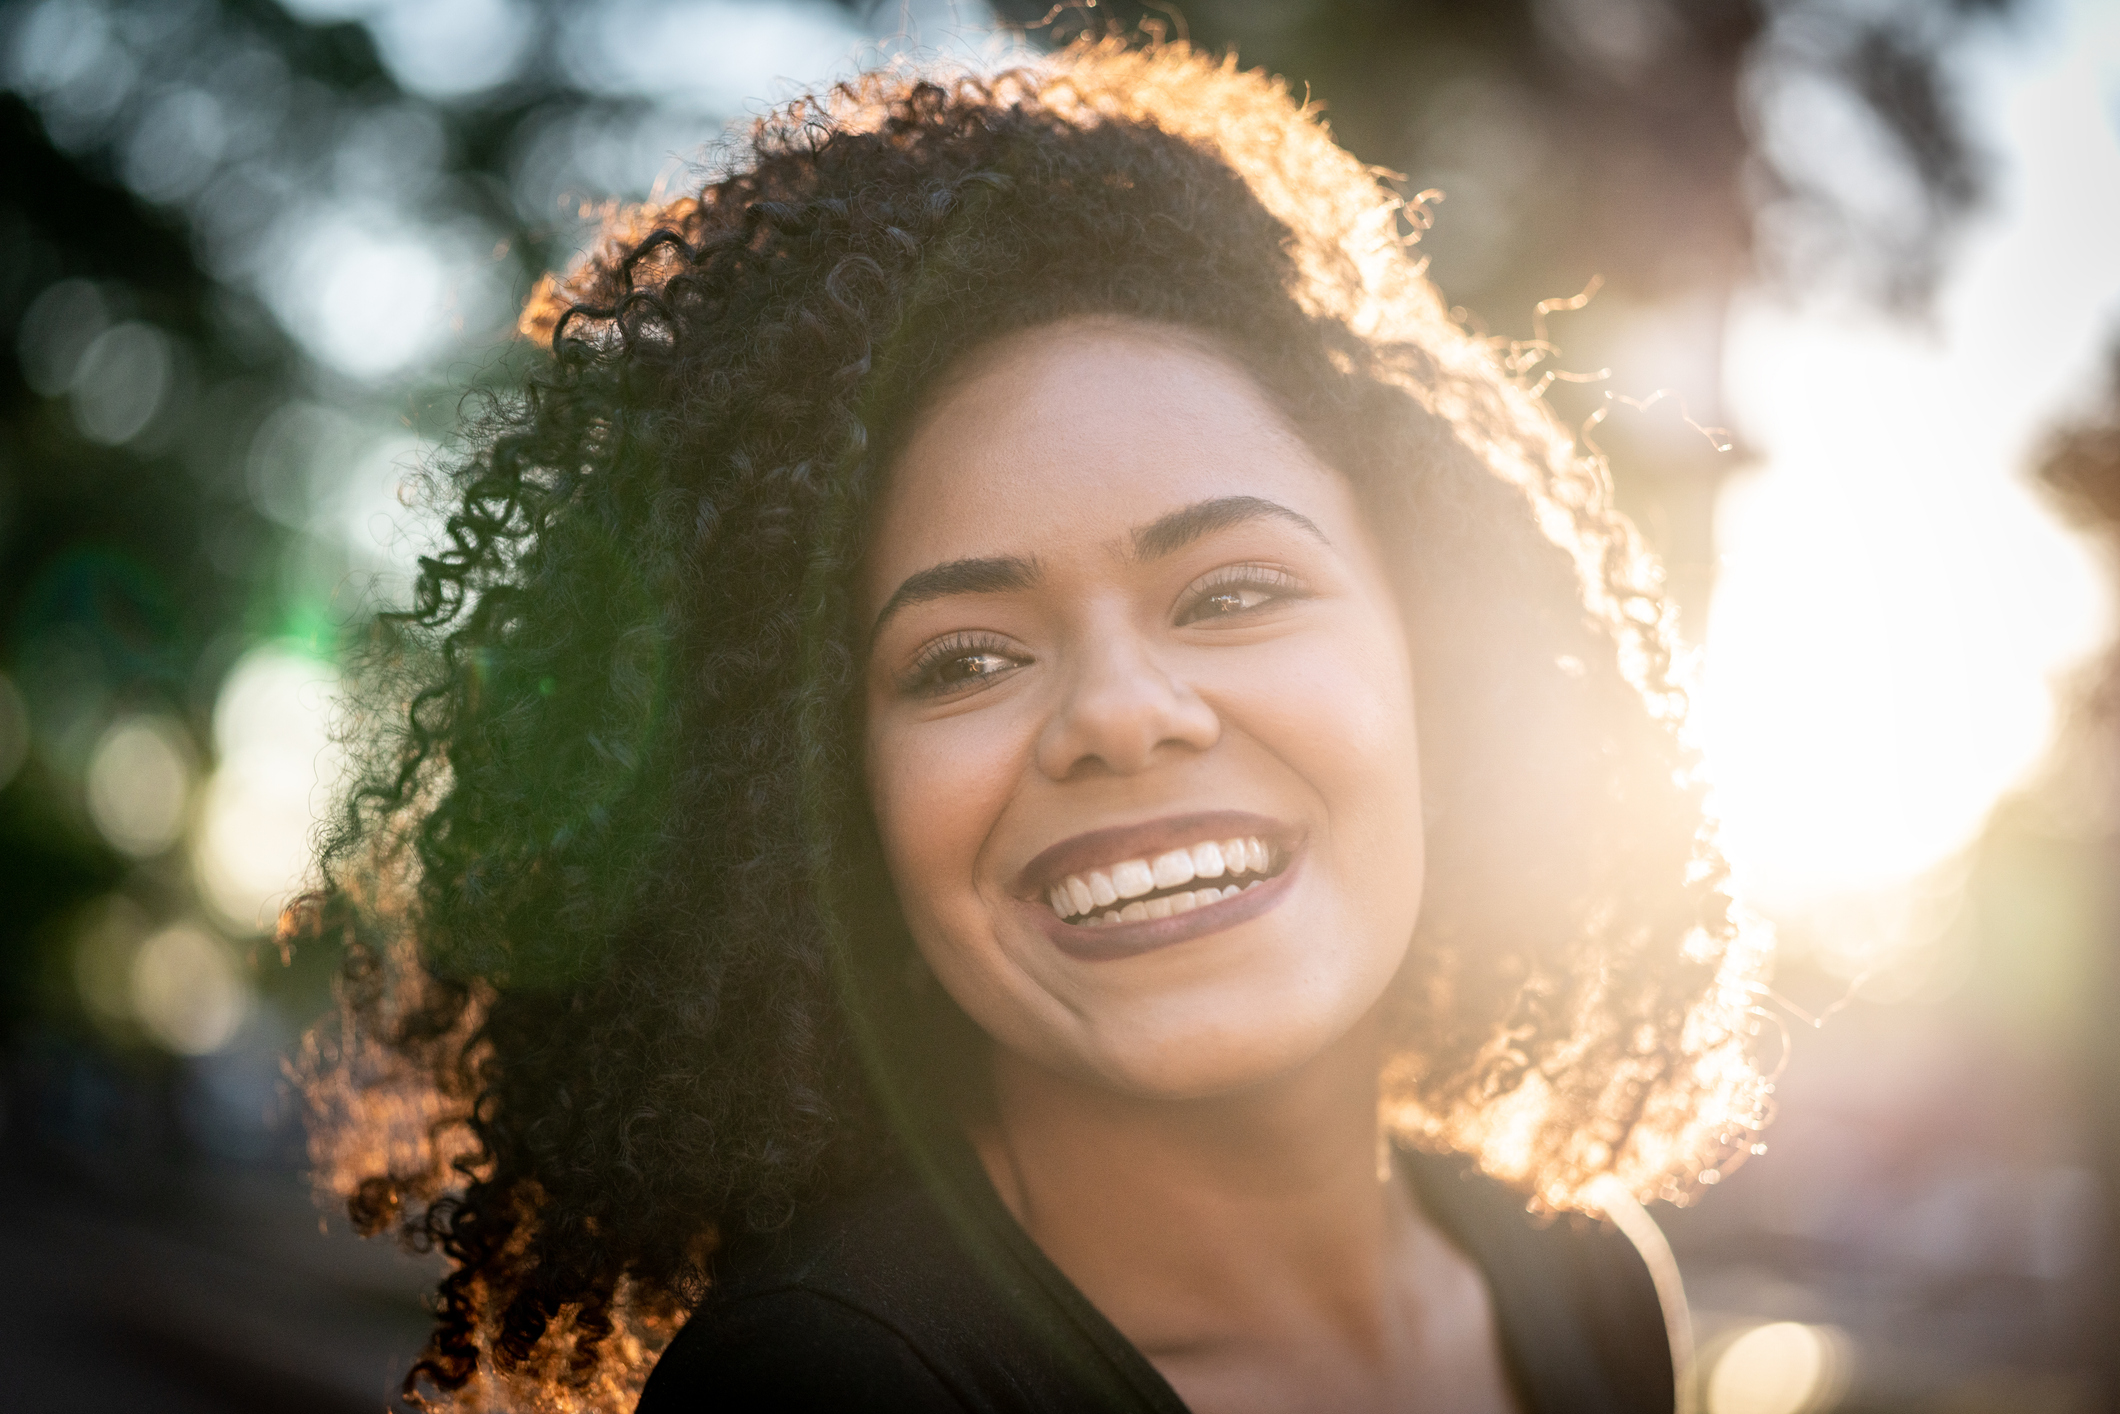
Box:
xmin=975 ymin=1026 xmax=1418 ymax=1359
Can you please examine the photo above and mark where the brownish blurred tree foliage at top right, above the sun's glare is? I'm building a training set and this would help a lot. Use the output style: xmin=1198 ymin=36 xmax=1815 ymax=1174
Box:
xmin=1005 ymin=0 xmax=2016 ymax=638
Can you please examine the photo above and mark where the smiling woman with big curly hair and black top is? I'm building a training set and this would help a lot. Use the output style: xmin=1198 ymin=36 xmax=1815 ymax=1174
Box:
xmin=307 ymin=45 xmax=1764 ymax=1414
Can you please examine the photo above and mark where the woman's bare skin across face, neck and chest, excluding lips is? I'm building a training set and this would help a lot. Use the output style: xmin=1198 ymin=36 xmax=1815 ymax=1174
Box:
xmin=865 ymin=320 xmax=1512 ymax=1414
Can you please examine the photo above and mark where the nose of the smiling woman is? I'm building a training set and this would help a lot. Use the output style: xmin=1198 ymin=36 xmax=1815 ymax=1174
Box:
xmin=1037 ymin=630 xmax=1221 ymax=780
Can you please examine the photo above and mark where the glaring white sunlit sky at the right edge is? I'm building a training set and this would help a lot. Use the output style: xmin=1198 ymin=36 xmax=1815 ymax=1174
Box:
xmin=1698 ymin=0 xmax=2120 ymax=928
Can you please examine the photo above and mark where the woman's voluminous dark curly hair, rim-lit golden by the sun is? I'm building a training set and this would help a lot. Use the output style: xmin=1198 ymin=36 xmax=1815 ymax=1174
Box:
xmin=298 ymin=40 xmax=1764 ymax=1408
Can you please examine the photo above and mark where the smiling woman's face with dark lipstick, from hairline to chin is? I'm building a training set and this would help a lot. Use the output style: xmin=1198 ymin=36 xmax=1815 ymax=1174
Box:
xmin=863 ymin=320 xmax=1423 ymax=1098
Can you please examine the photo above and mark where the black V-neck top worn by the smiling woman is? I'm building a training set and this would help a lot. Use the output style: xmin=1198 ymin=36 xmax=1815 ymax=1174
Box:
xmin=638 ymin=1143 xmax=1683 ymax=1414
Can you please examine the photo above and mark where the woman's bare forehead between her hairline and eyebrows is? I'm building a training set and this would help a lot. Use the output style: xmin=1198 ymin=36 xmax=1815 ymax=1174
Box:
xmin=869 ymin=320 xmax=1344 ymax=580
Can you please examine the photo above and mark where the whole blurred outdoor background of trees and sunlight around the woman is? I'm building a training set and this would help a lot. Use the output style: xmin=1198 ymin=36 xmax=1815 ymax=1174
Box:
xmin=0 ymin=0 xmax=2120 ymax=1414
